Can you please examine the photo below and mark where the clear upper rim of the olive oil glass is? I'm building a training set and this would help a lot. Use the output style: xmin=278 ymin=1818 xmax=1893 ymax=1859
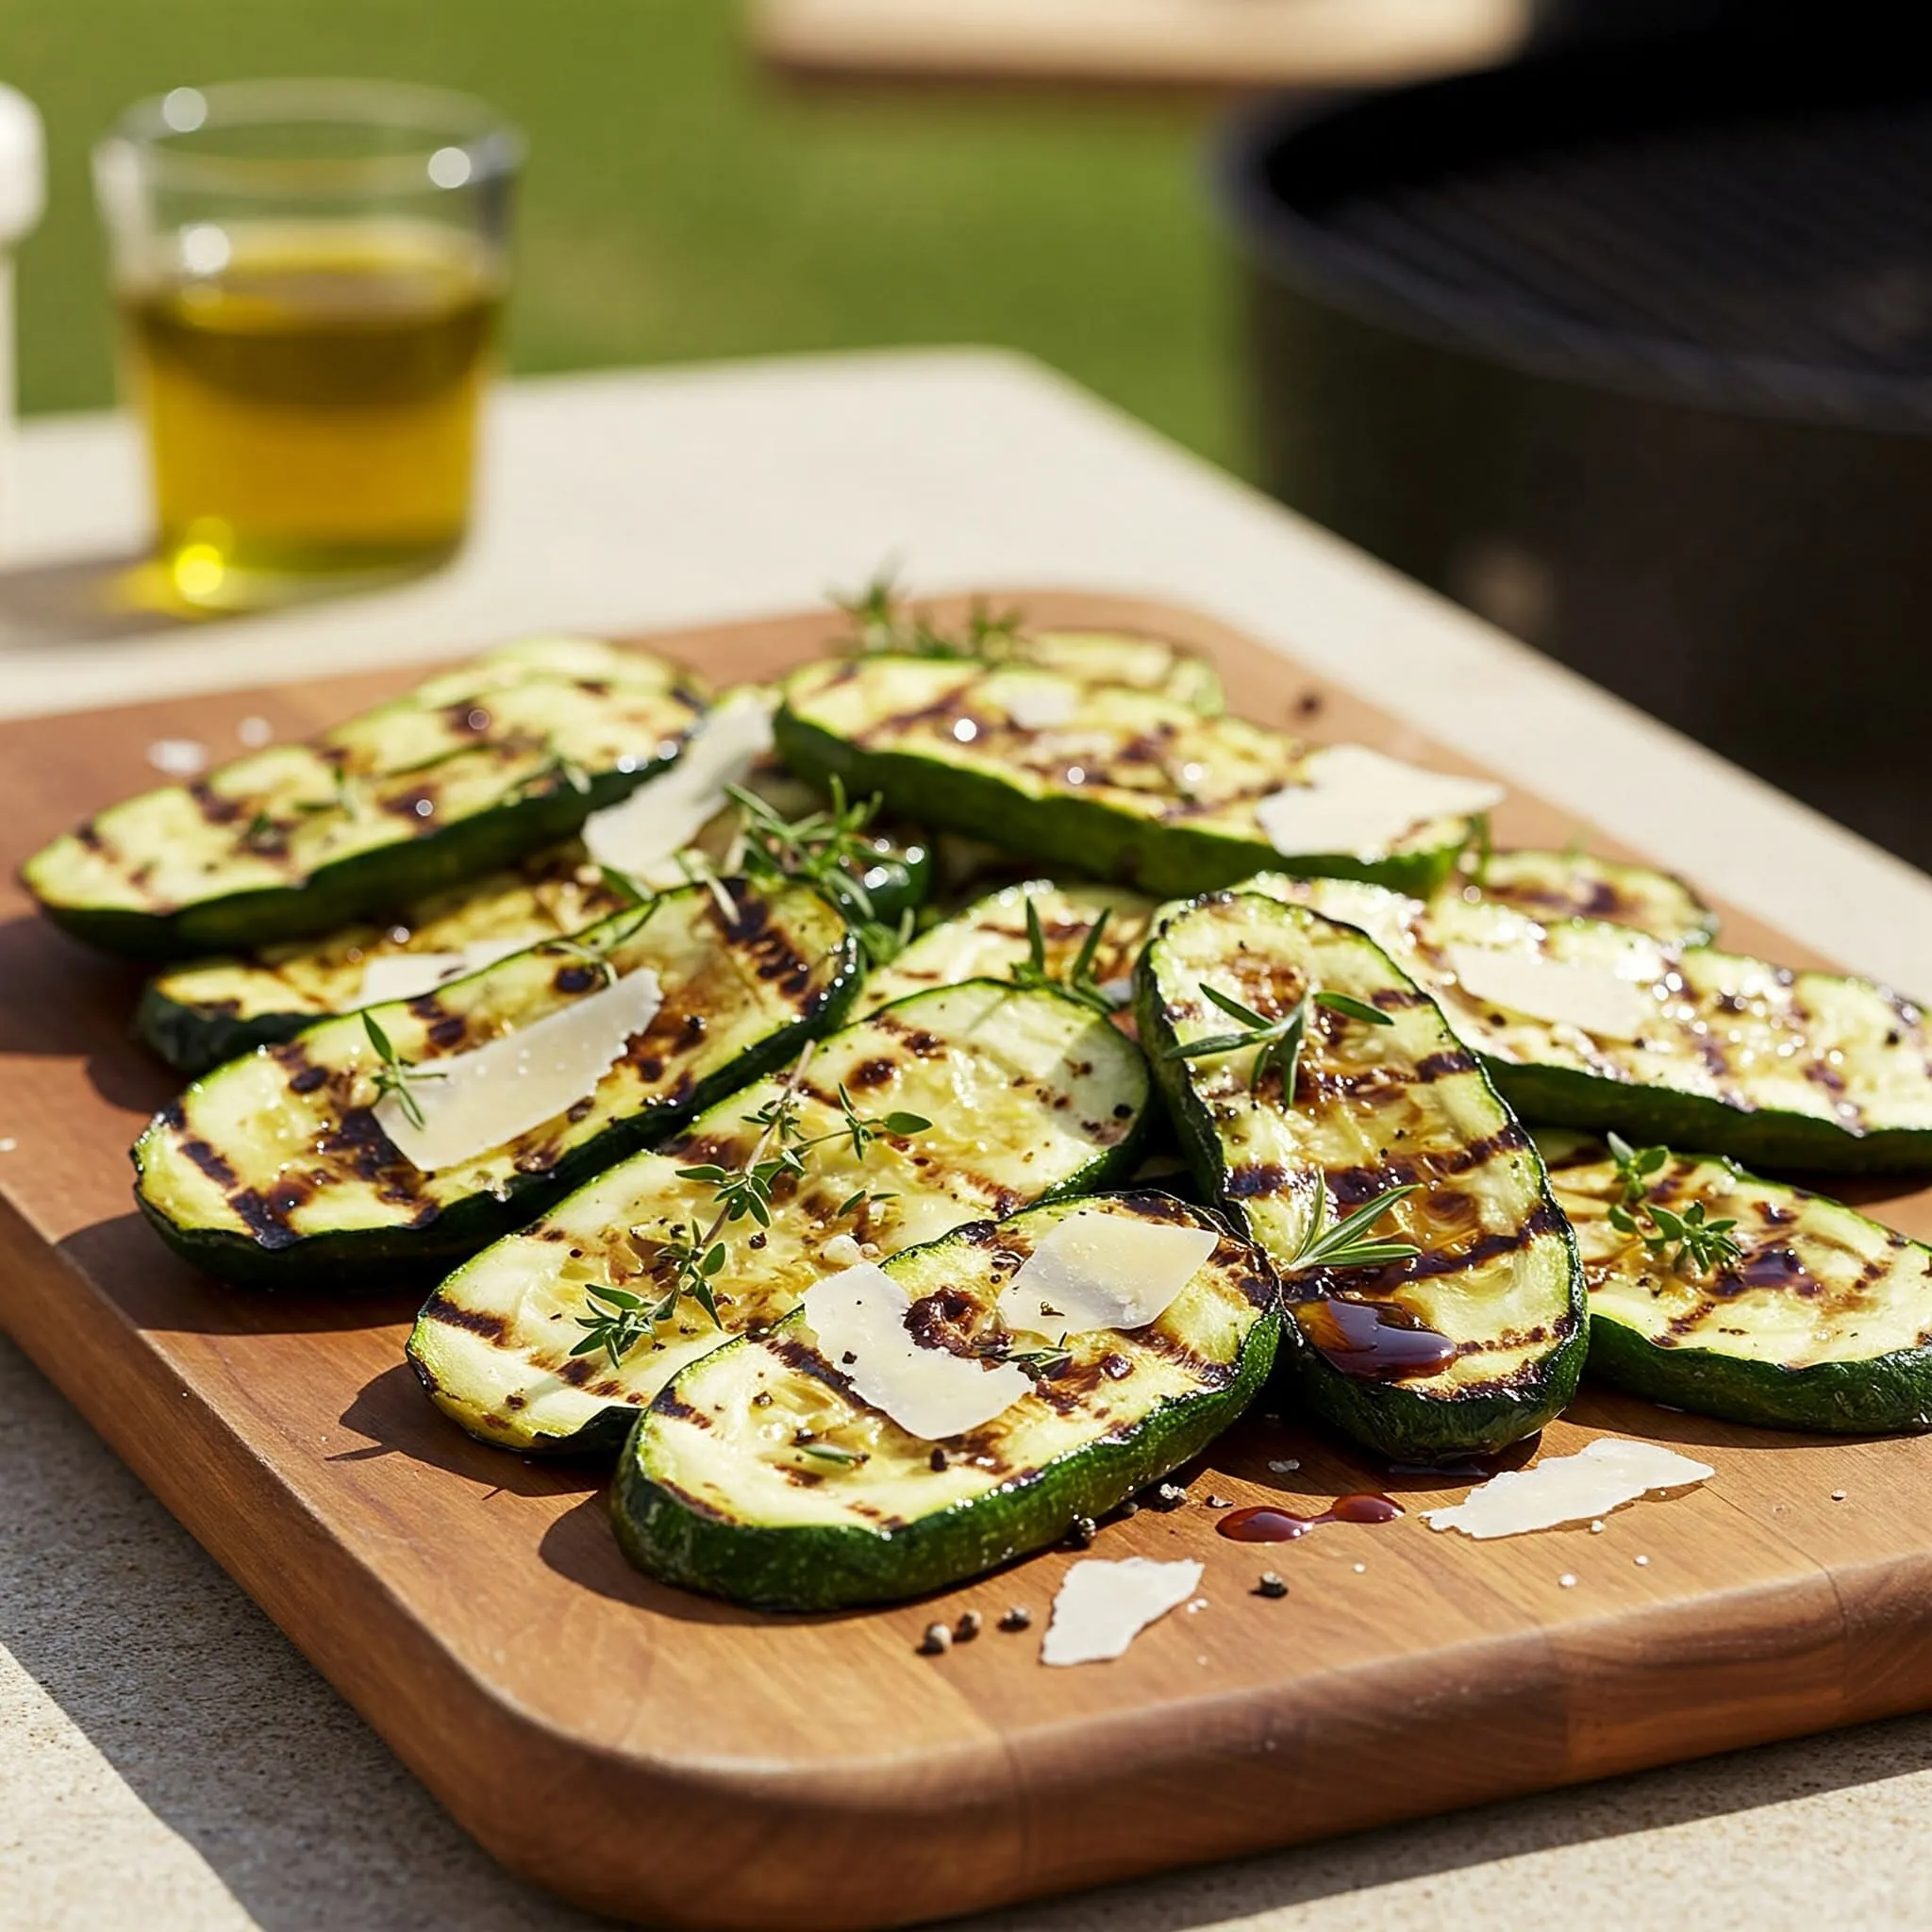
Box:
xmin=94 ymin=79 xmax=525 ymax=199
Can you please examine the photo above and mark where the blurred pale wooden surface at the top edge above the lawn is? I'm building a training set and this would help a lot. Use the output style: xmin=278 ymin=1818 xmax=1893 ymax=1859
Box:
xmin=752 ymin=0 xmax=1530 ymax=89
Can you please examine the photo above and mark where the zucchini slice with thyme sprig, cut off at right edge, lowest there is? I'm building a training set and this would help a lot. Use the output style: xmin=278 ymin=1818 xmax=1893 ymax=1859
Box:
xmin=1538 ymin=1128 xmax=1932 ymax=1436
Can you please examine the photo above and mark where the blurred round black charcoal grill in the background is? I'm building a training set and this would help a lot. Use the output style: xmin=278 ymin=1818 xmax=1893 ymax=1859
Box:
xmin=1219 ymin=35 xmax=1932 ymax=866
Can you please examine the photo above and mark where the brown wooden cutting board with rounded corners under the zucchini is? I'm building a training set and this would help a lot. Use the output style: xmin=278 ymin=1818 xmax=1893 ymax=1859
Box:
xmin=0 ymin=593 xmax=1932 ymax=1932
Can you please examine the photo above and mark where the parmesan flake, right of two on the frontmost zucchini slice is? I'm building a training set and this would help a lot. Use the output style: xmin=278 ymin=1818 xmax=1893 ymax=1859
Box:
xmin=999 ymin=1209 xmax=1221 ymax=1337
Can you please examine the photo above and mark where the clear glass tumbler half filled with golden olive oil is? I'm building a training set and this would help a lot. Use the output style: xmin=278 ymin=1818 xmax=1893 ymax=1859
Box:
xmin=94 ymin=81 xmax=522 ymax=610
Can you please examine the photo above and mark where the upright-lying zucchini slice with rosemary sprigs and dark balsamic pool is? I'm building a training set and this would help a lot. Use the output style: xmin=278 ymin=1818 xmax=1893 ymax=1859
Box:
xmin=1136 ymin=892 xmax=1586 ymax=1462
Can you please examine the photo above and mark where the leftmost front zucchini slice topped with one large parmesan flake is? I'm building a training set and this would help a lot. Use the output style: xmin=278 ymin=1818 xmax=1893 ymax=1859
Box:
xmin=133 ymin=881 xmax=858 ymax=1289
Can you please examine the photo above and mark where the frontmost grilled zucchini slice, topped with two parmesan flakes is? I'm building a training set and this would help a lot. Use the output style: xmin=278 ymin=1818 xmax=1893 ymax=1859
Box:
xmin=610 ymin=1194 xmax=1281 ymax=1609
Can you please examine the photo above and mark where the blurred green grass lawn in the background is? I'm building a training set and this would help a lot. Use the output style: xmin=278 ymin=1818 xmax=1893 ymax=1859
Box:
xmin=0 ymin=0 xmax=1239 ymax=461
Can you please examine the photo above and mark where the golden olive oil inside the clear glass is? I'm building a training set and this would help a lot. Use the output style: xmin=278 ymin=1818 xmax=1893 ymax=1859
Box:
xmin=122 ymin=220 xmax=502 ymax=607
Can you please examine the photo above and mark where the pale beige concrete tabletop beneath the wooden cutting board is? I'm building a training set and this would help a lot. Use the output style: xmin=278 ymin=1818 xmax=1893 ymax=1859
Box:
xmin=11 ymin=352 xmax=1932 ymax=1932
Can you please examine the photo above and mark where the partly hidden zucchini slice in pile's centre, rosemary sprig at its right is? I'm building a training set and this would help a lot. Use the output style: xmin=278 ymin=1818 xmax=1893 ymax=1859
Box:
xmin=856 ymin=879 xmax=1154 ymax=1014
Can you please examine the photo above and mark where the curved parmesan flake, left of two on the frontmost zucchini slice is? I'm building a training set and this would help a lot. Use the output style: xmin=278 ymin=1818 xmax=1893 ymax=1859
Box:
xmin=806 ymin=1261 xmax=1032 ymax=1441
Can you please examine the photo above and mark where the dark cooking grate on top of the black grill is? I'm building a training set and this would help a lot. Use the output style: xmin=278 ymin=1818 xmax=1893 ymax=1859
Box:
xmin=1275 ymin=48 xmax=1932 ymax=409
